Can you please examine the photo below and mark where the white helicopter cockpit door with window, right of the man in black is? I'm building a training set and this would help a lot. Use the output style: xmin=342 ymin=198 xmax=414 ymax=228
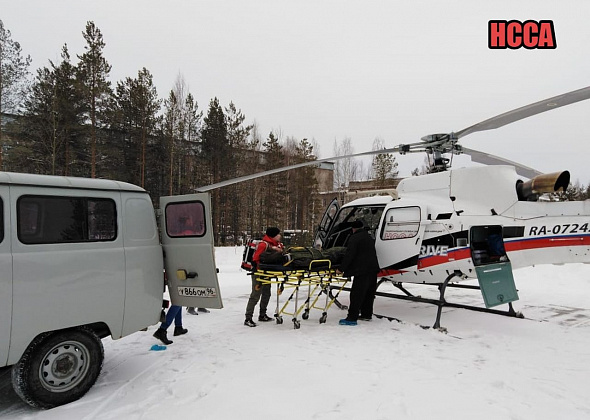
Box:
xmin=375 ymin=201 xmax=429 ymax=270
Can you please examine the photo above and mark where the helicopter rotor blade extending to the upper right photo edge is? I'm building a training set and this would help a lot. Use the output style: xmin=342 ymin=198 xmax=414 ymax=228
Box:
xmin=453 ymin=86 xmax=590 ymax=139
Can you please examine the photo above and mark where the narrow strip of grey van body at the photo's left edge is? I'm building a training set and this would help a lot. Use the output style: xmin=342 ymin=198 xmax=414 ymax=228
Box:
xmin=0 ymin=185 xmax=12 ymax=366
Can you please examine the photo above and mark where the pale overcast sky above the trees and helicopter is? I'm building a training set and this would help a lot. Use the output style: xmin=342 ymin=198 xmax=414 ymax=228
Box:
xmin=0 ymin=0 xmax=590 ymax=185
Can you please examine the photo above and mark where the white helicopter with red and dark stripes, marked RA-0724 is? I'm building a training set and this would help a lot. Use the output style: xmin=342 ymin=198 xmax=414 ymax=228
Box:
xmin=199 ymin=87 xmax=590 ymax=328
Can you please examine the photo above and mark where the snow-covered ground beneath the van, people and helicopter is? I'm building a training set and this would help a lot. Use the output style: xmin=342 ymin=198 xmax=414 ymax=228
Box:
xmin=0 ymin=248 xmax=590 ymax=420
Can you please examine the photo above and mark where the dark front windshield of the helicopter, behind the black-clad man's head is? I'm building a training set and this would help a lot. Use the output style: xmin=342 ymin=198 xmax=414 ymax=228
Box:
xmin=324 ymin=205 xmax=385 ymax=248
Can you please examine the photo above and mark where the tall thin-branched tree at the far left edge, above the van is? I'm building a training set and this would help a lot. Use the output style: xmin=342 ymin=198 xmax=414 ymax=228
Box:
xmin=0 ymin=19 xmax=31 ymax=170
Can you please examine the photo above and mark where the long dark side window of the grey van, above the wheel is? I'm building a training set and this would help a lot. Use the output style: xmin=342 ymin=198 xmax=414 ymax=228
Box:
xmin=16 ymin=195 xmax=117 ymax=244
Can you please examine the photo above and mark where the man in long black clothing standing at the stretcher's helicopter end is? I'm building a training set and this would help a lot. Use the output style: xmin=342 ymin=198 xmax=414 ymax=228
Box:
xmin=339 ymin=220 xmax=379 ymax=325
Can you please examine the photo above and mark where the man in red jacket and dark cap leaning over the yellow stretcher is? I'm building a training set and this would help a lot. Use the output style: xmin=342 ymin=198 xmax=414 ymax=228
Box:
xmin=244 ymin=227 xmax=284 ymax=327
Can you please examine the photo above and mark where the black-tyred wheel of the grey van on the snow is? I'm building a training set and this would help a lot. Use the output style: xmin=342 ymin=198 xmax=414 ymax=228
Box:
xmin=12 ymin=328 xmax=104 ymax=408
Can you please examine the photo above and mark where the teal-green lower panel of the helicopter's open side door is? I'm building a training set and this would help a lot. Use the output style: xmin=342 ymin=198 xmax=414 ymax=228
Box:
xmin=475 ymin=262 xmax=518 ymax=308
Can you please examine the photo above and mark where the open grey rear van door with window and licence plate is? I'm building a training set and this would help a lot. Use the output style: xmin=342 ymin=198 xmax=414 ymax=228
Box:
xmin=160 ymin=193 xmax=223 ymax=309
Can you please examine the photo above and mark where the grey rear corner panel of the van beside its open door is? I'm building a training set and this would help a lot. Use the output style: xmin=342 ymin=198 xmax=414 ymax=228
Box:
xmin=121 ymin=193 xmax=164 ymax=338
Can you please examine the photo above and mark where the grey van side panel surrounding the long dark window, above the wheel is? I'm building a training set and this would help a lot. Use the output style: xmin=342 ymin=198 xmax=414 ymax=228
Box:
xmin=8 ymin=185 xmax=125 ymax=364
